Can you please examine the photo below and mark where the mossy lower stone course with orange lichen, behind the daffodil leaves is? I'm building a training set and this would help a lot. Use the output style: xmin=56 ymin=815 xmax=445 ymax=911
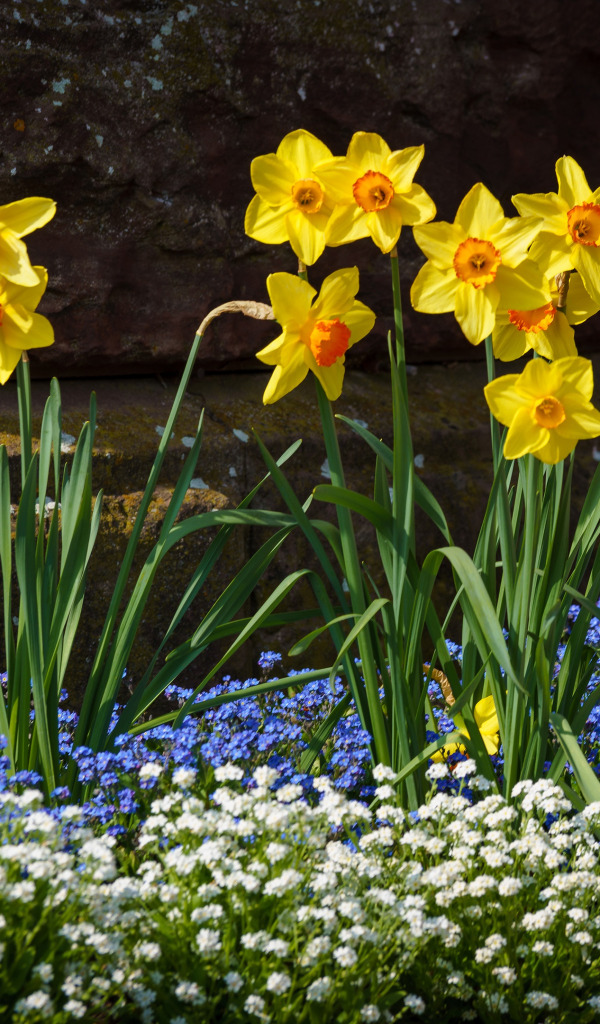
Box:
xmin=0 ymin=359 xmax=600 ymax=708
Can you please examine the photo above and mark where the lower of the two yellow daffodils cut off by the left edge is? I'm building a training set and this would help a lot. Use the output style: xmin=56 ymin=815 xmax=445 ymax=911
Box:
xmin=0 ymin=266 xmax=54 ymax=384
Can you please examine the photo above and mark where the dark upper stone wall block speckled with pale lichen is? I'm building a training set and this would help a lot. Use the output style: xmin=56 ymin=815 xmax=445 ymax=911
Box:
xmin=0 ymin=0 xmax=600 ymax=379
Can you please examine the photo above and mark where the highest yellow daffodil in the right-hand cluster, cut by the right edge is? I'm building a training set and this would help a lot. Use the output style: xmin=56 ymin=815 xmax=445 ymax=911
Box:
xmin=513 ymin=157 xmax=600 ymax=302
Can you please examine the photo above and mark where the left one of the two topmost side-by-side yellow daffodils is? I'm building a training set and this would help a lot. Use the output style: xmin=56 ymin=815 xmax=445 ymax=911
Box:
xmin=246 ymin=128 xmax=333 ymax=266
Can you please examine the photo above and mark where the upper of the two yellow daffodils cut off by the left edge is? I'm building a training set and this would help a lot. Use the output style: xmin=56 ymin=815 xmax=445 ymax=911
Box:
xmin=0 ymin=197 xmax=56 ymax=288
